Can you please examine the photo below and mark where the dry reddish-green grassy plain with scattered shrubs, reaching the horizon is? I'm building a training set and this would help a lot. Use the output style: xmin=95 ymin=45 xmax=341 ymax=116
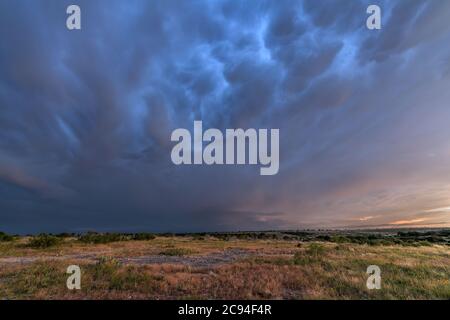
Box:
xmin=0 ymin=230 xmax=450 ymax=299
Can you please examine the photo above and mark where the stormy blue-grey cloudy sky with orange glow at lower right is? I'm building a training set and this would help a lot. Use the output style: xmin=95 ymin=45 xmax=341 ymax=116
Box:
xmin=0 ymin=0 xmax=450 ymax=233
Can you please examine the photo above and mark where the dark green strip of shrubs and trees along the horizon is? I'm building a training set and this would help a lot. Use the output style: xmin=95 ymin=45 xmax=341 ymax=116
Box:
xmin=0 ymin=229 xmax=450 ymax=248
